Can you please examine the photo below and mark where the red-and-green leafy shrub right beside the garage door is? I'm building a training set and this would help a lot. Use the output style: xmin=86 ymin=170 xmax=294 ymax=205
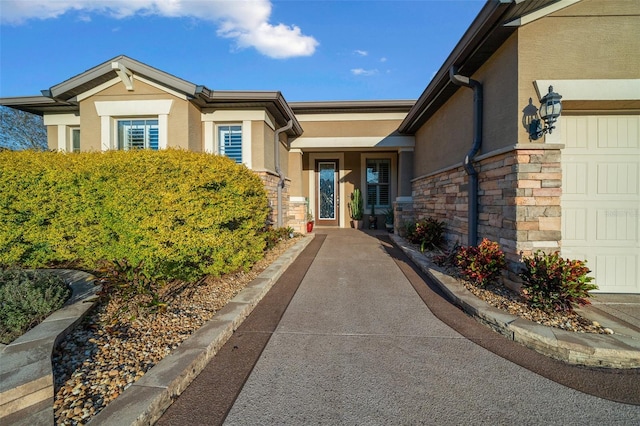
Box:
xmin=519 ymin=251 xmax=598 ymax=312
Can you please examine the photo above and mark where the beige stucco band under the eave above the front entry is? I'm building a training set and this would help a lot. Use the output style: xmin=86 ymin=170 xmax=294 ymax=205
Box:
xmin=299 ymin=116 xmax=402 ymax=138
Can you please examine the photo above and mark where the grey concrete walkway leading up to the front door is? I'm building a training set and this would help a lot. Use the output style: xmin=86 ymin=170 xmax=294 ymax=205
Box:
xmin=159 ymin=230 xmax=640 ymax=425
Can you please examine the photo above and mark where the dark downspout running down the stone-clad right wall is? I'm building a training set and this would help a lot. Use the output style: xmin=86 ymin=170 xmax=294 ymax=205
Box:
xmin=449 ymin=67 xmax=482 ymax=246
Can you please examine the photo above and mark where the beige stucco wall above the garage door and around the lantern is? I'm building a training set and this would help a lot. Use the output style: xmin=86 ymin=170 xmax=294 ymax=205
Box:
xmin=518 ymin=0 xmax=640 ymax=142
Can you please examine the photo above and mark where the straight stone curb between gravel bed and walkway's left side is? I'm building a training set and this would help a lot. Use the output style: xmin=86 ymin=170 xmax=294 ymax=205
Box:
xmin=88 ymin=234 xmax=315 ymax=425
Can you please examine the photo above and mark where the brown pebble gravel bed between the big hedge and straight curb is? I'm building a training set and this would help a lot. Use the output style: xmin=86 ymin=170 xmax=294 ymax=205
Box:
xmin=52 ymin=239 xmax=297 ymax=425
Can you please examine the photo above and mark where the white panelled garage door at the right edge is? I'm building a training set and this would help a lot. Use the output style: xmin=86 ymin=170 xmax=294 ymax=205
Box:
xmin=561 ymin=115 xmax=640 ymax=293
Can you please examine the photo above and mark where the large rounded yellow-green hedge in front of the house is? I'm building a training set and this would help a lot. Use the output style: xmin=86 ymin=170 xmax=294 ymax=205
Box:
xmin=0 ymin=150 xmax=268 ymax=280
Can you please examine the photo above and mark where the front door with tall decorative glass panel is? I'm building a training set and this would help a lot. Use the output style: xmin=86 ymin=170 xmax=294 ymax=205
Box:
xmin=315 ymin=160 xmax=340 ymax=226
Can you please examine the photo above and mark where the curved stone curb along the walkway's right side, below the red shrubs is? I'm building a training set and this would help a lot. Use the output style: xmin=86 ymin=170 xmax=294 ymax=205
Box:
xmin=391 ymin=234 xmax=640 ymax=369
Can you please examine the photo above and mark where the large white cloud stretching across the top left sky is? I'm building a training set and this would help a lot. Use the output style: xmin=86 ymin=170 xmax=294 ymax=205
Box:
xmin=0 ymin=0 xmax=319 ymax=58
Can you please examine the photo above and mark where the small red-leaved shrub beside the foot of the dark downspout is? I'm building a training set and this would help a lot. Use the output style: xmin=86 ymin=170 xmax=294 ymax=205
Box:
xmin=456 ymin=238 xmax=506 ymax=286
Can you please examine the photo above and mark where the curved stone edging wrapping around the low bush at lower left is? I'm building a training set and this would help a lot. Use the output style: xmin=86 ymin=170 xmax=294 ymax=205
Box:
xmin=0 ymin=269 xmax=102 ymax=424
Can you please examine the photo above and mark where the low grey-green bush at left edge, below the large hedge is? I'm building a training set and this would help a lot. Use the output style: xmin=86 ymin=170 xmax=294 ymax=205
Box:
xmin=0 ymin=270 xmax=71 ymax=344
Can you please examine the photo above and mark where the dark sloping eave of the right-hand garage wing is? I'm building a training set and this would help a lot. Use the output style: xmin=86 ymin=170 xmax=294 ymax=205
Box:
xmin=399 ymin=0 xmax=580 ymax=134
